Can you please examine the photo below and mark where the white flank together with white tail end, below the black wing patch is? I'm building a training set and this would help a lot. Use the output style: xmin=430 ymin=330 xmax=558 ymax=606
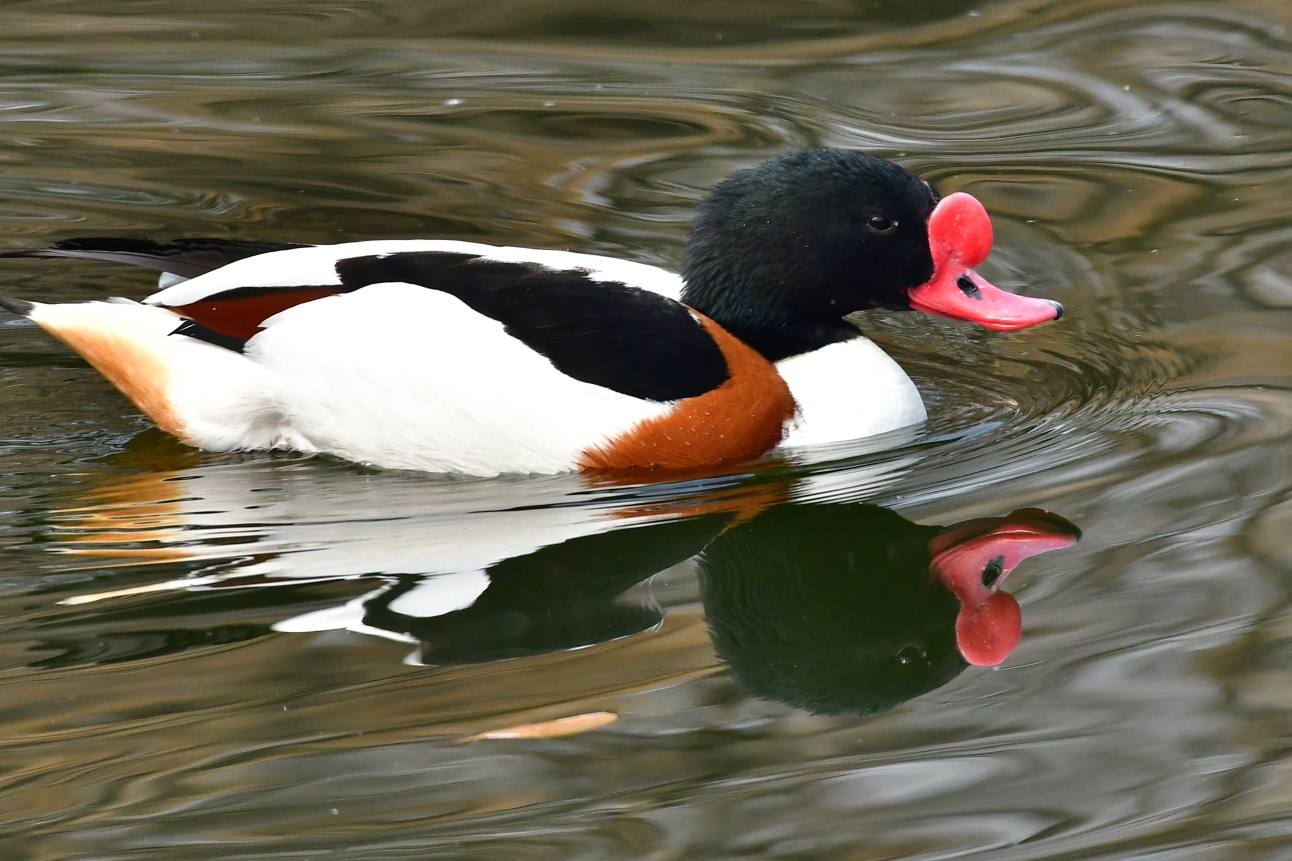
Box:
xmin=31 ymin=284 xmax=668 ymax=476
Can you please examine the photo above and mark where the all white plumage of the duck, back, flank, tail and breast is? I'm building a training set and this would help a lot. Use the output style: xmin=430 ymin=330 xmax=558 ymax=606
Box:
xmin=28 ymin=240 xmax=925 ymax=474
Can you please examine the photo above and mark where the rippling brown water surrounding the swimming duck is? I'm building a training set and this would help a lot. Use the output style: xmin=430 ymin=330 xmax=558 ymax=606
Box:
xmin=0 ymin=0 xmax=1292 ymax=861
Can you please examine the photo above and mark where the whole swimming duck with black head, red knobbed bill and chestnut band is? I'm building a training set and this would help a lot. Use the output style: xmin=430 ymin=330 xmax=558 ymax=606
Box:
xmin=0 ymin=149 xmax=1063 ymax=476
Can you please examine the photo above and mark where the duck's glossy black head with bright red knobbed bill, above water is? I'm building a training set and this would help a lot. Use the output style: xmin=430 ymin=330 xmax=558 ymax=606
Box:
xmin=682 ymin=150 xmax=1063 ymax=362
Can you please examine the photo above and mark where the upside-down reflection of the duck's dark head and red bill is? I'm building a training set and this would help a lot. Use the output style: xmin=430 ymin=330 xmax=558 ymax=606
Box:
xmin=699 ymin=503 xmax=1079 ymax=714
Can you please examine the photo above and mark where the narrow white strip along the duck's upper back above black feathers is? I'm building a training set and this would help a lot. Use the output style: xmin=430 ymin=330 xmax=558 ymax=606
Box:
xmin=145 ymin=239 xmax=682 ymax=306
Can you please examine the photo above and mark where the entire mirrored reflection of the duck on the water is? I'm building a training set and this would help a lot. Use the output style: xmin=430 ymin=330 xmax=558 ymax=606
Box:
xmin=50 ymin=455 xmax=1080 ymax=714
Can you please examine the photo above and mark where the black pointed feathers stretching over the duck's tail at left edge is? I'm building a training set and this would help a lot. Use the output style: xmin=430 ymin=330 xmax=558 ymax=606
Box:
xmin=0 ymin=237 xmax=301 ymax=278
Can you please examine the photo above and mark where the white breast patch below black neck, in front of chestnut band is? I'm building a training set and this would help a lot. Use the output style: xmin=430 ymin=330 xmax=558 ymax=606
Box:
xmin=776 ymin=337 xmax=928 ymax=447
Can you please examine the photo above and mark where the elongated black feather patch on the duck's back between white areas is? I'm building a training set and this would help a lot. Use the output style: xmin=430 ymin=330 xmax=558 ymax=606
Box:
xmin=336 ymin=252 xmax=727 ymax=401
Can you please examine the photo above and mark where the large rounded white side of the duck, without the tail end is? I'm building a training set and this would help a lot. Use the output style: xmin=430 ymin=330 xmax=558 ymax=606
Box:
xmin=247 ymin=283 xmax=668 ymax=476
